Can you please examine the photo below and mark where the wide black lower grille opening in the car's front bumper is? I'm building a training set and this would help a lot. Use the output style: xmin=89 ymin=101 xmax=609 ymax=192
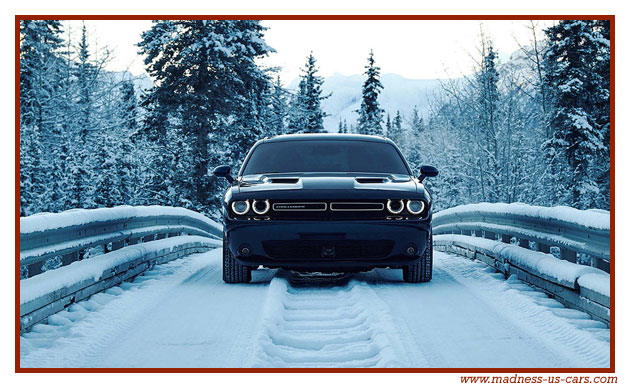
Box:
xmin=263 ymin=240 xmax=394 ymax=260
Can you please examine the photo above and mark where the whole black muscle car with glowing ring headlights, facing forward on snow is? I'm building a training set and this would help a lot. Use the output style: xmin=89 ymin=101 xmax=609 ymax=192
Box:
xmin=214 ymin=134 xmax=438 ymax=283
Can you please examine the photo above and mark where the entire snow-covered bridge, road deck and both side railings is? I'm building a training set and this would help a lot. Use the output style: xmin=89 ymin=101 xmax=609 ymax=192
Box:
xmin=19 ymin=204 xmax=611 ymax=367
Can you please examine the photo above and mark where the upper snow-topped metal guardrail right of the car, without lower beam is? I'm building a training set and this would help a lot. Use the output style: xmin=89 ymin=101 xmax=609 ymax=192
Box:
xmin=433 ymin=203 xmax=610 ymax=273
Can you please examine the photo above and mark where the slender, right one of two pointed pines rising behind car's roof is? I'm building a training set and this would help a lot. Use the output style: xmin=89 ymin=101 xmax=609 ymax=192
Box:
xmin=357 ymin=50 xmax=383 ymax=135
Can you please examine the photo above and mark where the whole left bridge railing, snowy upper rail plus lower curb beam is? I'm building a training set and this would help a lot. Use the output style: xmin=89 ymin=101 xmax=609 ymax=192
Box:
xmin=20 ymin=206 xmax=222 ymax=332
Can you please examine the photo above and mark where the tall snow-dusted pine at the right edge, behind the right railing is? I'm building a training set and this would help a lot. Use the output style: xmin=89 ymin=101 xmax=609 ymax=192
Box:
xmin=545 ymin=20 xmax=610 ymax=209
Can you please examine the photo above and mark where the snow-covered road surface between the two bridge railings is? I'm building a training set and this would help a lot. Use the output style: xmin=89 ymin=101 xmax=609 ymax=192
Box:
xmin=20 ymin=249 xmax=610 ymax=367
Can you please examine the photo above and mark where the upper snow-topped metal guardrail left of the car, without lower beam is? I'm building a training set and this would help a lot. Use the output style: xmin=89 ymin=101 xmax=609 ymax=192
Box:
xmin=20 ymin=206 xmax=222 ymax=278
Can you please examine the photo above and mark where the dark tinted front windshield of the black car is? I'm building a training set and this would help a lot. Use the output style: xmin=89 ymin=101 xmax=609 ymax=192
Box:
xmin=243 ymin=140 xmax=409 ymax=175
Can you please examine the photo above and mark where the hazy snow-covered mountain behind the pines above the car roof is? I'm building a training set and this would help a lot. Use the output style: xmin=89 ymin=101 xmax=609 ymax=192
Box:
xmin=289 ymin=73 xmax=439 ymax=132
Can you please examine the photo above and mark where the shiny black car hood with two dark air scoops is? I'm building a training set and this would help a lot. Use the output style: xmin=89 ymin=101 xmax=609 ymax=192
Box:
xmin=235 ymin=174 xmax=418 ymax=193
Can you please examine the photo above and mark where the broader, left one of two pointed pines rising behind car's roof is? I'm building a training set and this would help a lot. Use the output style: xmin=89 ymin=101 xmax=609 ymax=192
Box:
xmin=287 ymin=52 xmax=330 ymax=133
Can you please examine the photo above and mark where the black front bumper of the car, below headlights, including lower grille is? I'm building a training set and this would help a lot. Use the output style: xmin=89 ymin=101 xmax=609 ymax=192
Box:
xmin=224 ymin=220 xmax=430 ymax=271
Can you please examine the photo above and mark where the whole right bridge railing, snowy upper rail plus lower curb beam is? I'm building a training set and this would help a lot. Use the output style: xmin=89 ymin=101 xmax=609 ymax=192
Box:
xmin=433 ymin=203 xmax=610 ymax=323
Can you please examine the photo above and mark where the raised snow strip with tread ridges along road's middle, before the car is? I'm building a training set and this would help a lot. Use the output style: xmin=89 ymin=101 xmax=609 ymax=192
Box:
xmin=249 ymin=273 xmax=422 ymax=367
